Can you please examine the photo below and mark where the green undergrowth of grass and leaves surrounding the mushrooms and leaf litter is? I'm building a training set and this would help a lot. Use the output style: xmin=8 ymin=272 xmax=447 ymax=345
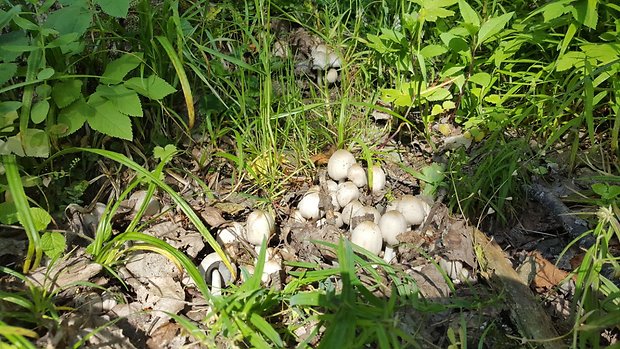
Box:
xmin=0 ymin=0 xmax=620 ymax=348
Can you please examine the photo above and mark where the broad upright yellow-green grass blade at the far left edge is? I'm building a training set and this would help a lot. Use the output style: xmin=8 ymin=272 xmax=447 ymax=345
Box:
xmin=2 ymin=155 xmax=43 ymax=274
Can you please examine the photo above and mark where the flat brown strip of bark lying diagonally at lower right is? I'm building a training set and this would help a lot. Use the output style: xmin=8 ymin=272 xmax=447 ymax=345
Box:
xmin=474 ymin=228 xmax=566 ymax=349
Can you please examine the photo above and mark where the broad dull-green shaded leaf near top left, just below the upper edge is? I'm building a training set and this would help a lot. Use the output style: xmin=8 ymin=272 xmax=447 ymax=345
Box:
xmin=43 ymin=4 xmax=92 ymax=36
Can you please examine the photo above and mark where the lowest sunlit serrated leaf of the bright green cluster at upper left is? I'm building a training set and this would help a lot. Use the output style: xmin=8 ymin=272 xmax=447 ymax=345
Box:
xmin=86 ymin=92 xmax=133 ymax=141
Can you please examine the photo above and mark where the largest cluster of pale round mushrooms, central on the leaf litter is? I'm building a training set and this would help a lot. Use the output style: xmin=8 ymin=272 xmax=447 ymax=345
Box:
xmin=293 ymin=149 xmax=430 ymax=263
